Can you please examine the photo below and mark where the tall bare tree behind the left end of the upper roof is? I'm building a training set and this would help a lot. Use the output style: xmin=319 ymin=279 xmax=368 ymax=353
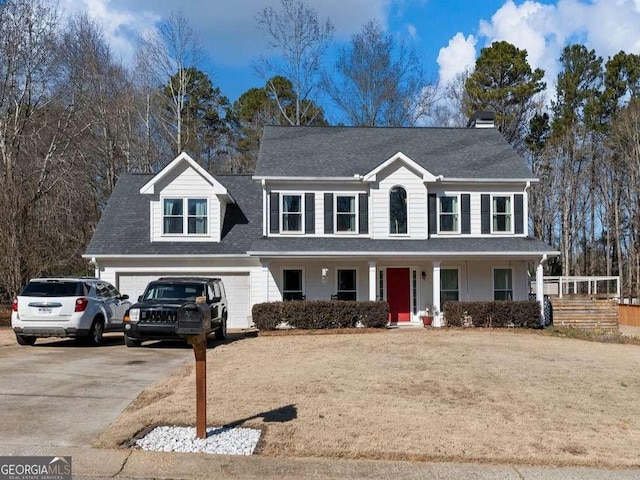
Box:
xmin=256 ymin=0 xmax=335 ymax=125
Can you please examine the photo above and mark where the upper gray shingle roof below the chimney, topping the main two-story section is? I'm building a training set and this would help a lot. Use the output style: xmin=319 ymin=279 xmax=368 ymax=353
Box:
xmin=256 ymin=126 xmax=533 ymax=179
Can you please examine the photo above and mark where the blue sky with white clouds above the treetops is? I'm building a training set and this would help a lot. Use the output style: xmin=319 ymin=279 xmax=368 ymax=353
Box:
xmin=59 ymin=0 xmax=640 ymax=105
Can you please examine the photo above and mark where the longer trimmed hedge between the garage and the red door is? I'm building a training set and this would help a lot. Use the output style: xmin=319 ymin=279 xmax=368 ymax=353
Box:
xmin=251 ymin=300 xmax=389 ymax=330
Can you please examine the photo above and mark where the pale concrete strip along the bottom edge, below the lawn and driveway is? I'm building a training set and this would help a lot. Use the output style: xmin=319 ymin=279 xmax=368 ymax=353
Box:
xmin=0 ymin=446 xmax=640 ymax=480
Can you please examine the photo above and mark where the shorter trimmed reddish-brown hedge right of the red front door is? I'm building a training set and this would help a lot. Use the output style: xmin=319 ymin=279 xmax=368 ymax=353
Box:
xmin=444 ymin=300 xmax=540 ymax=328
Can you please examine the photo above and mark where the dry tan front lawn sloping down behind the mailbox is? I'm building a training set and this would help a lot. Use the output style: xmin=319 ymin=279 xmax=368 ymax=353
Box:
xmin=97 ymin=330 xmax=640 ymax=467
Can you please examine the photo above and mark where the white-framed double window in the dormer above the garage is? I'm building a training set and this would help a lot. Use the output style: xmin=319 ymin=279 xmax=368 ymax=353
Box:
xmin=162 ymin=198 xmax=209 ymax=235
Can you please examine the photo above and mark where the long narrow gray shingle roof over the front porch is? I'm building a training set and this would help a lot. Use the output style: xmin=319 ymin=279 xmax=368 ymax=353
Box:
xmin=248 ymin=237 xmax=560 ymax=258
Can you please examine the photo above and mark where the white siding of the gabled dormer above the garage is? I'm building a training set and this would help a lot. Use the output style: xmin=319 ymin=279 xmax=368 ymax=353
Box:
xmin=151 ymin=164 xmax=224 ymax=242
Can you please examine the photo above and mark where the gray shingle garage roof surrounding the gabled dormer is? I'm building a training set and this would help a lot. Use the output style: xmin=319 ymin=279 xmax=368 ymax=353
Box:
xmin=85 ymin=174 xmax=262 ymax=256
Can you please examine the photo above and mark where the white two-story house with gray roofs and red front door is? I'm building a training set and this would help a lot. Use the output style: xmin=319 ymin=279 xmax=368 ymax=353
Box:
xmin=85 ymin=115 xmax=557 ymax=328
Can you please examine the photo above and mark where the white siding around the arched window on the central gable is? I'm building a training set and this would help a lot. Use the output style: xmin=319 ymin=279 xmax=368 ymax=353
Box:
xmin=370 ymin=162 xmax=427 ymax=239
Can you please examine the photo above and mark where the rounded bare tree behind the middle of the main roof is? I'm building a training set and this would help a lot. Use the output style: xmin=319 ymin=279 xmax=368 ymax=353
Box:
xmin=323 ymin=20 xmax=435 ymax=127
